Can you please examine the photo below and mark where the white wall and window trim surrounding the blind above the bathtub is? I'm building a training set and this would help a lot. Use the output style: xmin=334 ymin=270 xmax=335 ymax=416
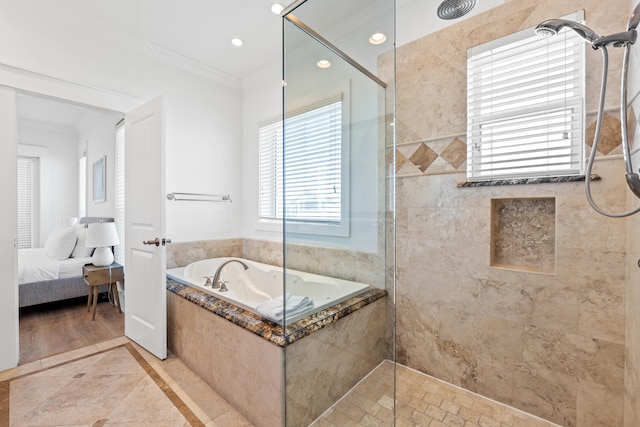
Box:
xmin=243 ymin=53 xmax=384 ymax=252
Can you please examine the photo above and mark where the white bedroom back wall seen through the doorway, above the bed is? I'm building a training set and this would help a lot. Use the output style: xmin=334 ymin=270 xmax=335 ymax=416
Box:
xmin=18 ymin=119 xmax=78 ymax=247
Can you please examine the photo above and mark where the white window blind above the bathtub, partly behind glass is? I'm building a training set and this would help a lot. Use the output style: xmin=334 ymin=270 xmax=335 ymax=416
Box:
xmin=259 ymin=99 xmax=343 ymax=224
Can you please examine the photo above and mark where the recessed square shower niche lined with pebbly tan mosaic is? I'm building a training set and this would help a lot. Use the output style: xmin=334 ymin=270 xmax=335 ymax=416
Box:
xmin=491 ymin=198 xmax=556 ymax=272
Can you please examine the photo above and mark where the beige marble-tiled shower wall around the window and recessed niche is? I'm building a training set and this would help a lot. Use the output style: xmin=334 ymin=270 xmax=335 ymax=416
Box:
xmin=379 ymin=0 xmax=637 ymax=426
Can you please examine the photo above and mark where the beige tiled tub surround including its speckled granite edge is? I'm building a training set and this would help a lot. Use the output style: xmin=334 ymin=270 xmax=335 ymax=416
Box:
xmin=167 ymin=279 xmax=387 ymax=427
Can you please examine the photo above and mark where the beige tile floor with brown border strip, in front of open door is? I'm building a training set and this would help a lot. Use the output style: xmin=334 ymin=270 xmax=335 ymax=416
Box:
xmin=0 ymin=337 xmax=251 ymax=427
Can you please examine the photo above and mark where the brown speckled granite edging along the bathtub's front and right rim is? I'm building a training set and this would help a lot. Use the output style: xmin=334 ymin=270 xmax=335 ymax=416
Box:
xmin=167 ymin=279 xmax=387 ymax=347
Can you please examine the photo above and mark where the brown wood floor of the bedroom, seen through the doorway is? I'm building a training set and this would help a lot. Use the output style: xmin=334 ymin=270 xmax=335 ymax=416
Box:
xmin=20 ymin=295 xmax=124 ymax=365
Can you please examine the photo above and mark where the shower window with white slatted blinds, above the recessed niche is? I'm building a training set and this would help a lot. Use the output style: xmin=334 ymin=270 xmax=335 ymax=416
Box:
xmin=467 ymin=12 xmax=585 ymax=181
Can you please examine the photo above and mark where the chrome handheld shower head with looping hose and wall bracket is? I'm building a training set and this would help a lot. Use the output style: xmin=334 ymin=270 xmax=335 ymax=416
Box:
xmin=535 ymin=7 xmax=640 ymax=218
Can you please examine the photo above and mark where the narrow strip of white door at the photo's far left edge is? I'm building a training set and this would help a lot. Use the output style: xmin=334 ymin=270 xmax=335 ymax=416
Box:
xmin=0 ymin=86 xmax=19 ymax=371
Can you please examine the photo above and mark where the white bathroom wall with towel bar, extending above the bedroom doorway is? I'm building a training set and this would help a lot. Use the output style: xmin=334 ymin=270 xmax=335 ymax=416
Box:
xmin=0 ymin=0 xmax=242 ymax=246
